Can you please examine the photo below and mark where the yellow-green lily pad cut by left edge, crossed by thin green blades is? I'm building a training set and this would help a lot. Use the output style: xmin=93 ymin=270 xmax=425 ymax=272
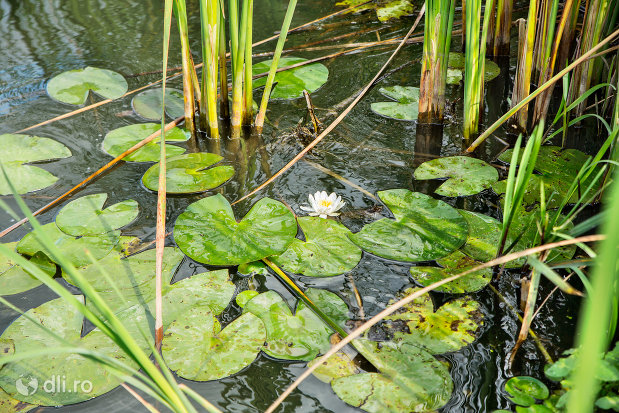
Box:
xmin=0 ymin=242 xmax=56 ymax=295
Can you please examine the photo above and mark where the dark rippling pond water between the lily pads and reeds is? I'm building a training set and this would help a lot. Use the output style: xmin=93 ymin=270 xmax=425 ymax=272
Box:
xmin=0 ymin=0 xmax=586 ymax=413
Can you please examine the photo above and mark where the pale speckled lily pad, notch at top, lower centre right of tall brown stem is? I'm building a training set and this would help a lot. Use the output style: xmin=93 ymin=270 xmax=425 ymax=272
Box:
xmin=161 ymin=307 xmax=266 ymax=381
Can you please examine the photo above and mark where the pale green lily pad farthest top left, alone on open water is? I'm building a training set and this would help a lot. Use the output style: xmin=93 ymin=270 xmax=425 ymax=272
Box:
xmin=47 ymin=66 xmax=128 ymax=105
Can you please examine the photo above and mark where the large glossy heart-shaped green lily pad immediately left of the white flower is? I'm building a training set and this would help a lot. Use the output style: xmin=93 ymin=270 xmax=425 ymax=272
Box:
xmin=174 ymin=194 xmax=297 ymax=266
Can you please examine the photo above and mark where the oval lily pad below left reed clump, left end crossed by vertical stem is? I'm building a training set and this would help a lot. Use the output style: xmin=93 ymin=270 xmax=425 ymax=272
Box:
xmin=142 ymin=152 xmax=234 ymax=194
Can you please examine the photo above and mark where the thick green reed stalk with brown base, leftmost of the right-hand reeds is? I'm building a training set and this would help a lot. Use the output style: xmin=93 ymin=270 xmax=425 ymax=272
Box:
xmin=417 ymin=0 xmax=456 ymax=123
